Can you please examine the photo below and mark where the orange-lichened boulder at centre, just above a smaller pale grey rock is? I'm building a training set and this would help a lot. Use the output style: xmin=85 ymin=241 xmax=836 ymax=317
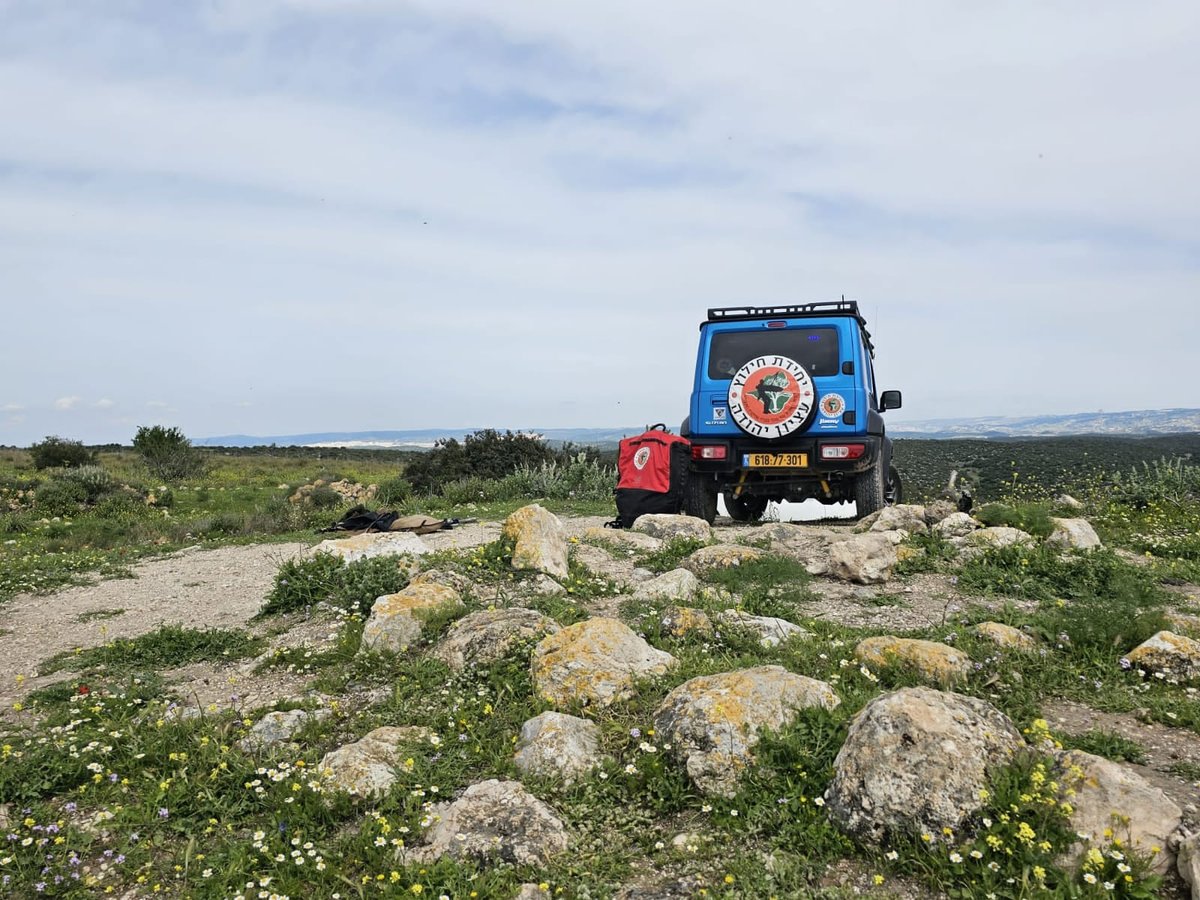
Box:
xmin=530 ymin=617 xmax=676 ymax=707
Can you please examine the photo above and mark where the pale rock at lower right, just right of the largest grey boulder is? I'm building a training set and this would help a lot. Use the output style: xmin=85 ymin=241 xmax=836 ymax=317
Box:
xmin=1058 ymin=750 xmax=1183 ymax=874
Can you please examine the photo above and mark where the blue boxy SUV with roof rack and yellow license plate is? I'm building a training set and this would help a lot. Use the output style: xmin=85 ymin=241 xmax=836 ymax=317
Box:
xmin=680 ymin=300 xmax=901 ymax=522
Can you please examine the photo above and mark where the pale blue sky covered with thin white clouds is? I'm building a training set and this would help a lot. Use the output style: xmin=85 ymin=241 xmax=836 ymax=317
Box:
xmin=0 ymin=0 xmax=1200 ymax=444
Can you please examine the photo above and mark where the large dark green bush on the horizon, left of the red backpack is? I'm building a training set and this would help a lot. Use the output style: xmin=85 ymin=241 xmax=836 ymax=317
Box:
xmin=404 ymin=428 xmax=554 ymax=493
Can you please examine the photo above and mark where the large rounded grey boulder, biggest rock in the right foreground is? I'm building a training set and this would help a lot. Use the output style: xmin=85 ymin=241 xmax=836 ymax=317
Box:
xmin=826 ymin=688 xmax=1025 ymax=845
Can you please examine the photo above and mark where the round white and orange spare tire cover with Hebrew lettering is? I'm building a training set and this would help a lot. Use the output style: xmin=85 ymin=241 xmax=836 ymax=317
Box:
xmin=730 ymin=356 xmax=816 ymax=438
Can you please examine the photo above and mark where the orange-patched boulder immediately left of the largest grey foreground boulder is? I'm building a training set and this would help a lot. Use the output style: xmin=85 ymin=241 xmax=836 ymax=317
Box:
xmin=654 ymin=666 xmax=840 ymax=797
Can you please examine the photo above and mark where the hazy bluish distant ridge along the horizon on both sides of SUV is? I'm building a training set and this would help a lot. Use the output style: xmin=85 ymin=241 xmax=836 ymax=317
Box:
xmin=193 ymin=409 xmax=1200 ymax=450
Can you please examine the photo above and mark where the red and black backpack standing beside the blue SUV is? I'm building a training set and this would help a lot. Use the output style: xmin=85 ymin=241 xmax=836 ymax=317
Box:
xmin=613 ymin=425 xmax=691 ymax=528
